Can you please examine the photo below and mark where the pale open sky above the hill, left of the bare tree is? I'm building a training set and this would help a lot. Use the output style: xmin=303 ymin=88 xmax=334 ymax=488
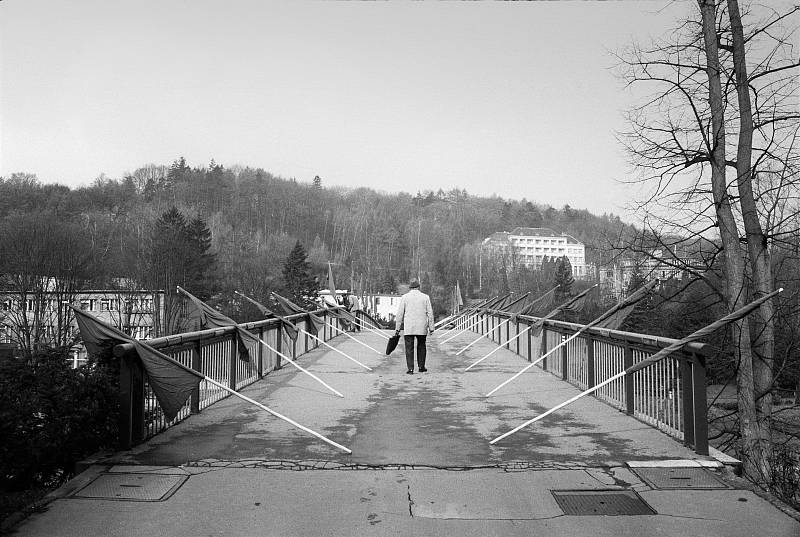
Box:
xmin=0 ymin=0 xmax=693 ymax=215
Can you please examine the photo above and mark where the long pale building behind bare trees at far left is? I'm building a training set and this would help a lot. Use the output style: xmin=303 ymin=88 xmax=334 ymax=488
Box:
xmin=0 ymin=289 xmax=164 ymax=366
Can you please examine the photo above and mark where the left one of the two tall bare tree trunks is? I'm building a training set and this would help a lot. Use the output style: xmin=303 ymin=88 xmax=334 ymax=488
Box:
xmin=698 ymin=0 xmax=766 ymax=479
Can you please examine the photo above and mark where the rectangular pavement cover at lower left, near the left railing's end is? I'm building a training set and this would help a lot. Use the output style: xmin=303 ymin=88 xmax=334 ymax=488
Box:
xmin=72 ymin=473 xmax=189 ymax=502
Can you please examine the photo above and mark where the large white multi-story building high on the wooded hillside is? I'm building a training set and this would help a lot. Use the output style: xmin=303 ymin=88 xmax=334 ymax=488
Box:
xmin=483 ymin=227 xmax=593 ymax=279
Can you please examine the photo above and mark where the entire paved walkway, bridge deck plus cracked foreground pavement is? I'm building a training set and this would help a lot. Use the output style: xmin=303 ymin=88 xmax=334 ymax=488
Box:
xmin=10 ymin=335 xmax=800 ymax=537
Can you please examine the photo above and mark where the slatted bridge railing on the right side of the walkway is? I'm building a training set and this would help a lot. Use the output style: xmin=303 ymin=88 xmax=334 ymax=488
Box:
xmin=456 ymin=310 xmax=709 ymax=455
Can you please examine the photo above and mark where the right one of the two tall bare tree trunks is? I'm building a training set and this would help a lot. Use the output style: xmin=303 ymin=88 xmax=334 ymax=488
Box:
xmin=728 ymin=0 xmax=775 ymax=428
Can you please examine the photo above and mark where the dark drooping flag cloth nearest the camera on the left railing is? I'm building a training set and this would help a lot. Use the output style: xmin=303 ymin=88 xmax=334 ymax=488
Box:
xmin=70 ymin=306 xmax=205 ymax=421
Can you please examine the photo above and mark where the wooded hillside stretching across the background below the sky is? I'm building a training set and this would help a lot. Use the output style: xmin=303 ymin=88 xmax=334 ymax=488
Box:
xmin=0 ymin=158 xmax=626 ymax=314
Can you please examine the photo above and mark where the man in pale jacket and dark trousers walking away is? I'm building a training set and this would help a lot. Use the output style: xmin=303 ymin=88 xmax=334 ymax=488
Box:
xmin=395 ymin=280 xmax=433 ymax=375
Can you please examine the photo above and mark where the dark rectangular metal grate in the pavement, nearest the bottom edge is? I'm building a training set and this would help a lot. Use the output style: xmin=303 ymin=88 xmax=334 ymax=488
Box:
xmin=550 ymin=490 xmax=656 ymax=516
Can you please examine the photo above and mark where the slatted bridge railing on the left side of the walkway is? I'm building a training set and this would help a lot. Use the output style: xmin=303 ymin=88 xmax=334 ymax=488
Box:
xmin=119 ymin=310 xmax=346 ymax=449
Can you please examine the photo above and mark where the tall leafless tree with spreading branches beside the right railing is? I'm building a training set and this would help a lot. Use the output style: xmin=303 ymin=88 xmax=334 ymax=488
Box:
xmin=620 ymin=0 xmax=800 ymax=482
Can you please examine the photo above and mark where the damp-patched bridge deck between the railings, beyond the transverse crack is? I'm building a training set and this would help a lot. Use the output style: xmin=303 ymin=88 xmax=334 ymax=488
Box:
xmin=116 ymin=333 xmax=699 ymax=467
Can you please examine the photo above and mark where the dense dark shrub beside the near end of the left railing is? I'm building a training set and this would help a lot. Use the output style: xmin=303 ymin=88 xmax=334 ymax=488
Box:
xmin=0 ymin=349 xmax=119 ymax=490
